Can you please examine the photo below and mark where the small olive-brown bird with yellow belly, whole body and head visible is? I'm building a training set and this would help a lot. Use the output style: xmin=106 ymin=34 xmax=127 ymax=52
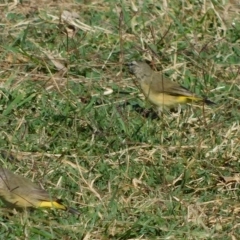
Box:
xmin=128 ymin=61 xmax=215 ymax=109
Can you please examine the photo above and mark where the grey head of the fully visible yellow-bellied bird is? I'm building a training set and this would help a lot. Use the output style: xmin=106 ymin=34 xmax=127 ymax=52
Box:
xmin=128 ymin=61 xmax=152 ymax=78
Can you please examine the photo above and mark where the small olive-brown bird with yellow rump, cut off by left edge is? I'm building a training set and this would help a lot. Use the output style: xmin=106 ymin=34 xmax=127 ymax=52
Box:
xmin=0 ymin=167 xmax=80 ymax=215
